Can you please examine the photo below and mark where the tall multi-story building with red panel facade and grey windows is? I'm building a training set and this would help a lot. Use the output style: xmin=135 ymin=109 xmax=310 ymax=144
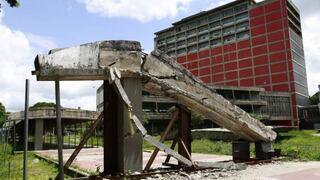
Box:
xmin=155 ymin=0 xmax=308 ymax=126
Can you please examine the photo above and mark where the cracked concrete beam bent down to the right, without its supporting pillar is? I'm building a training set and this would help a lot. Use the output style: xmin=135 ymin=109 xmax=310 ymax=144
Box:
xmin=34 ymin=41 xmax=276 ymax=141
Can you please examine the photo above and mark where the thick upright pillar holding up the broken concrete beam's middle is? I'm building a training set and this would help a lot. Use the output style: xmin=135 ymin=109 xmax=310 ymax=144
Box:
xmin=104 ymin=78 xmax=142 ymax=174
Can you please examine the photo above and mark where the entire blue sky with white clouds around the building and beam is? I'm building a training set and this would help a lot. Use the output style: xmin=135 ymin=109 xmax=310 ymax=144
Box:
xmin=0 ymin=0 xmax=320 ymax=111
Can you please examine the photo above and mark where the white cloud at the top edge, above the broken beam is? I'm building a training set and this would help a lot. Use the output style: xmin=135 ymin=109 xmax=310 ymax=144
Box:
xmin=77 ymin=0 xmax=193 ymax=22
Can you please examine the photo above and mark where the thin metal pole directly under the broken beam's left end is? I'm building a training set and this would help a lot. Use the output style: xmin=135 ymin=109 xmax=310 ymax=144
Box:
xmin=55 ymin=80 xmax=64 ymax=180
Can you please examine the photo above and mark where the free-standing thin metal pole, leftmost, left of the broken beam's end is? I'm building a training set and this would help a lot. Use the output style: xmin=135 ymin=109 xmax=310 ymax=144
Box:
xmin=23 ymin=79 xmax=29 ymax=180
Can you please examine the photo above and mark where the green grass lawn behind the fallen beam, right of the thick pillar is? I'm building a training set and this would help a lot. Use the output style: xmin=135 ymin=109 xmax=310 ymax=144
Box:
xmin=143 ymin=130 xmax=320 ymax=161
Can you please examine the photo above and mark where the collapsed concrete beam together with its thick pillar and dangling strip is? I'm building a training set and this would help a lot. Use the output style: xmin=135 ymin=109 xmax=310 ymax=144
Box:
xmin=34 ymin=41 xmax=276 ymax=173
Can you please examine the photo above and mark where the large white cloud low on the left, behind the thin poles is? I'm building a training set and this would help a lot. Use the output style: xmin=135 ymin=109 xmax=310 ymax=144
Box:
xmin=0 ymin=16 xmax=101 ymax=111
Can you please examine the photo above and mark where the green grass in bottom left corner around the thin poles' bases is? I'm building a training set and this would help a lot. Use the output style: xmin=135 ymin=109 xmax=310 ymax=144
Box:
xmin=0 ymin=144 xmax=69 ymax=180
